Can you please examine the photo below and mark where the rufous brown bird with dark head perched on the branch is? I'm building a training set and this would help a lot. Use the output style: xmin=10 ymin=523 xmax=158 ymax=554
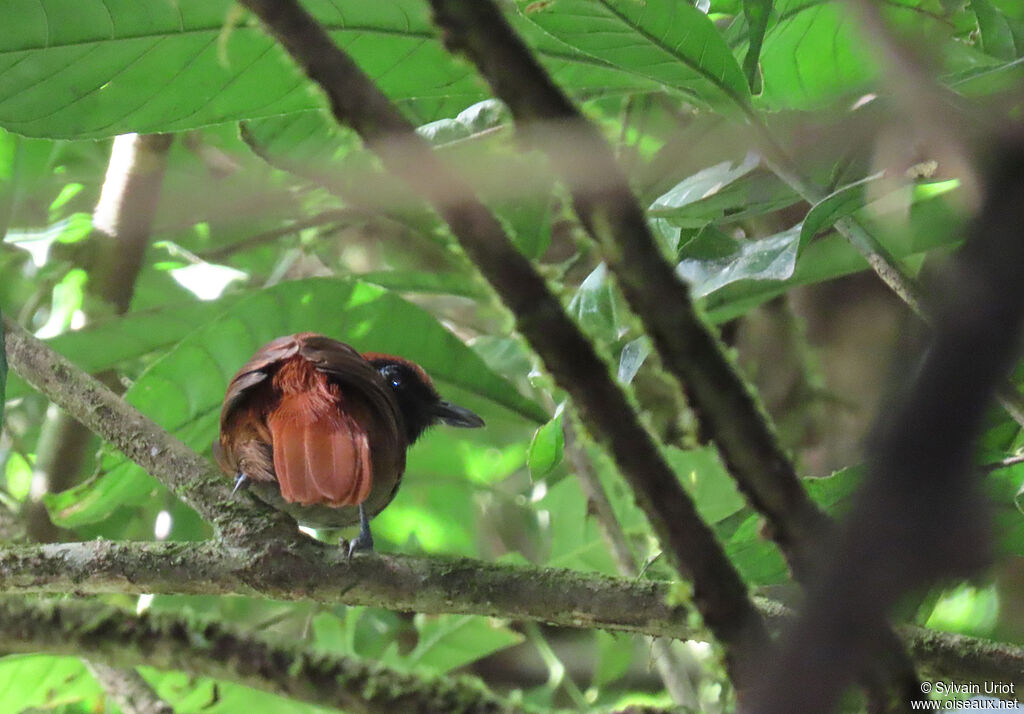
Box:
xmin=214 ymin=332 xmax=483 ymax=554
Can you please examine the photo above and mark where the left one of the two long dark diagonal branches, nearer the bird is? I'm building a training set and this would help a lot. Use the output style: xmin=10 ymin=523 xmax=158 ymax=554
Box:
xmin=237 ymin=0 xmax=767 ymax=681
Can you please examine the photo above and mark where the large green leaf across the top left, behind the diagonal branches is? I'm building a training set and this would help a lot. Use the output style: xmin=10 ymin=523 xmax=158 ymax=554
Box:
xmin=0 ymin=0 xmax=650 ymax=138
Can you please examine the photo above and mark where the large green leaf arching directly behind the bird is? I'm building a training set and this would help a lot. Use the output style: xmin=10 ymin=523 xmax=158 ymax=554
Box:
xmin=47 ymin=279 xmax=547 ymax=528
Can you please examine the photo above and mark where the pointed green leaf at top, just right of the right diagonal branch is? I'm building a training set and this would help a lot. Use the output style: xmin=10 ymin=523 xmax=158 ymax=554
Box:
xmin=517 ymin=0 xmax=750 ymax=112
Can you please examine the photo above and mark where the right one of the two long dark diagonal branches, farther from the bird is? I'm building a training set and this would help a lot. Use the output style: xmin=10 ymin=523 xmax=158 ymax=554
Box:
xmin=430 ymin=0 xmax=828 ymax=576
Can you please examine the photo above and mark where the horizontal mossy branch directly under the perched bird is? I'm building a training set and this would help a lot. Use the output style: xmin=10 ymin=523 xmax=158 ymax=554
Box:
xmin=0 ymin=539 xmax=691 ymax=638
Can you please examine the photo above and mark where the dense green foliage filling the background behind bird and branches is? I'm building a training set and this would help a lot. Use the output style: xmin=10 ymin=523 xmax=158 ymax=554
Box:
xmin=0 ymin=0 xmax=1024 ymax=712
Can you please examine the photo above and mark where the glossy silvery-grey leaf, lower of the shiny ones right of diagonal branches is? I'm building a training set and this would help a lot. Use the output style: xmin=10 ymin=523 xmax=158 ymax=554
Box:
xmin=677 ymin=226 xmax=800 ymax=297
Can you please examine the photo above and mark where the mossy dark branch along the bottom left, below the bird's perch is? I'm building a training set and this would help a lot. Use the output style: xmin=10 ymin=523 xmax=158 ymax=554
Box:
xmin=0 ymin=598 xmax=525 ymax=714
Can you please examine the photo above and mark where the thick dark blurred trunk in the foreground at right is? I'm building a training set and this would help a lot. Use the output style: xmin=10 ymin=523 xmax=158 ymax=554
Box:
xmin=750 ymin=137 xmax=1024 ymax=714
